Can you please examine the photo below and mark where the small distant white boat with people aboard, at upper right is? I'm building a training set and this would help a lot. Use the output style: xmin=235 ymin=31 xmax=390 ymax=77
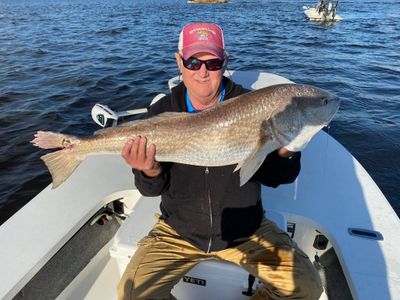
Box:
xmin=303 ymin=0 xmax=342 ymax=22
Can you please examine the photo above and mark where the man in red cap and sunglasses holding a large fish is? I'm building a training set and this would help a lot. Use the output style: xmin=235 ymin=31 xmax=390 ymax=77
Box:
xmin=118 ymin=23 xmax=322 ymax=299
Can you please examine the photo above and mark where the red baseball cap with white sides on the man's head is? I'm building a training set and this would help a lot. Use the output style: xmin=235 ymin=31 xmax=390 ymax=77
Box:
xmin=178 ymin=23 xmax=225 ymax=59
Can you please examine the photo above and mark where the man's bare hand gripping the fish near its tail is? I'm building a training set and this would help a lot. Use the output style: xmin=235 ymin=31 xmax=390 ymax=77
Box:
xmin=121 ymin=136 xmax=161 ymax=177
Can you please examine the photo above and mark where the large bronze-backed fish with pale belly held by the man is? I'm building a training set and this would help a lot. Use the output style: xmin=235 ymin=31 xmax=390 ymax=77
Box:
xmin=31 ymin=83 xmax=340 ymax=188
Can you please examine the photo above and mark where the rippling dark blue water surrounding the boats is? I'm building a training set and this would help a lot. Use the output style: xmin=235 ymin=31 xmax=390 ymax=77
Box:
xmin=0 ymin=0 xmax=400 ymax=223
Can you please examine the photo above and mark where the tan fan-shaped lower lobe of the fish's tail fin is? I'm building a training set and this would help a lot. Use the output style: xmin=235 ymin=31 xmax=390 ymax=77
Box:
xmin=40 ymin=149 xmax=86 ymax=189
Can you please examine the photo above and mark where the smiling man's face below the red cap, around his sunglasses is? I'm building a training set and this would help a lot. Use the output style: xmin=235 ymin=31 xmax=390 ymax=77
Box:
xmin=175 ymin=52 xmax=224 ymax=104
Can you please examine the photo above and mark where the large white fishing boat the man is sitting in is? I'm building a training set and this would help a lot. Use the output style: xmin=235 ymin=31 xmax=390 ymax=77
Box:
xmin=0 ymin=71 xmax=400 ymax=300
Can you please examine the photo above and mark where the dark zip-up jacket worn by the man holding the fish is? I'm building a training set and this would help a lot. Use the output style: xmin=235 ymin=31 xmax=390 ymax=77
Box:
xmin=133 ymin=78 xmax=300 ymax=252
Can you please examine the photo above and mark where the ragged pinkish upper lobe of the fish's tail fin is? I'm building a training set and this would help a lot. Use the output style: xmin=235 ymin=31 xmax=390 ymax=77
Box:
xmin=31 ymin=131 xmax=80 ymax=149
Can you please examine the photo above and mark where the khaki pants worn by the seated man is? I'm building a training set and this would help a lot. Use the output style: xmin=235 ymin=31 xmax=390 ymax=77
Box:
xmin=118 ymin=219 xmax=322 ymax=300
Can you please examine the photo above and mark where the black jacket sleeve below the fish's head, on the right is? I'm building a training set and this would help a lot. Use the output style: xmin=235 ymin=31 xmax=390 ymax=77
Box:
xmin=252 ymin=150 xmax=301 ymax=188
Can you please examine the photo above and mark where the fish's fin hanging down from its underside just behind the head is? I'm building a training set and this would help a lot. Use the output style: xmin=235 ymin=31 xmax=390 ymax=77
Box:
xmin=235 ymin=121 xmax=279 ymax=186
